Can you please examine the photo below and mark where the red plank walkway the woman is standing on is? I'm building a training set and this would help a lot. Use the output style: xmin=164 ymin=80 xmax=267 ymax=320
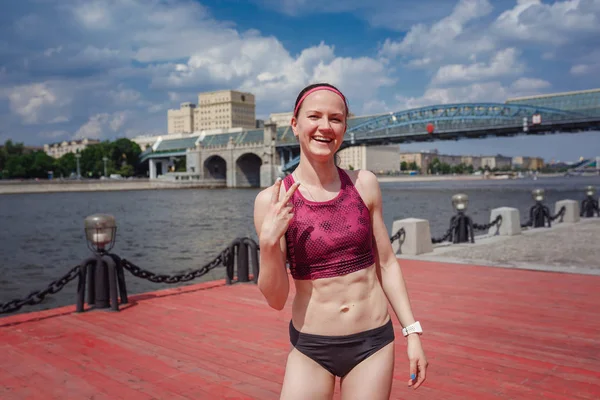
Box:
xmin=0 ymin=260 xmax=600 ymax=400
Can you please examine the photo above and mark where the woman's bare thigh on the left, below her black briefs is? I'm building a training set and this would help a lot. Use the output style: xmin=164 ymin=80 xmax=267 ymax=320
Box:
xmin=281 ymin=348 xmax=335 ymax=400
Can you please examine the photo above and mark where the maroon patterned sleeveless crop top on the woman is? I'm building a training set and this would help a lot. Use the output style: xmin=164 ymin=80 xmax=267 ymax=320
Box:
xmin=283 ymin=168 xmax=375 ymax=280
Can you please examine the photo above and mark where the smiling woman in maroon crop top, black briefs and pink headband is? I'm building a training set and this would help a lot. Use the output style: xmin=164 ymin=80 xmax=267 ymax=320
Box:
xmin=254 ymin=84 xmax=427 ymax=400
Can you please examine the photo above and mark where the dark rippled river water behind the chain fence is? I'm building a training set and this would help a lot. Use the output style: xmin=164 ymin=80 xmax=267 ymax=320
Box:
xmin=0 ymin=176 xmax=600 ymax=312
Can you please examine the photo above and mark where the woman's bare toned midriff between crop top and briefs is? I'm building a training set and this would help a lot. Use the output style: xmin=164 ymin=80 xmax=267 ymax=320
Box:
xmin=292 ymin=265 xmax=389 ymax=336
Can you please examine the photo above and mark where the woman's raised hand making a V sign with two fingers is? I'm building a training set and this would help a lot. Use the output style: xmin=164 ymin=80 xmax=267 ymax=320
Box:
xmin=259 ymin=178 xmax=300 ymax=244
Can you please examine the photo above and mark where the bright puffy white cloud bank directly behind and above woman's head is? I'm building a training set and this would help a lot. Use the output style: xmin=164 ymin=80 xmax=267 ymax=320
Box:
xmin=161 ymin=36 xmax=394 ymax=112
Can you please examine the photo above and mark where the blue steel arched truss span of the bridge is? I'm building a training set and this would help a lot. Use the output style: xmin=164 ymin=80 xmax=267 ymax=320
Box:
xmin=278 ymin=103 xmax=600 ymax=171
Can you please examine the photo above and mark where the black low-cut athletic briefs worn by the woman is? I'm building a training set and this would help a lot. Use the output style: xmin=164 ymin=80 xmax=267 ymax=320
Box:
xmin=290 ymin=319 xmax=395 ymax=377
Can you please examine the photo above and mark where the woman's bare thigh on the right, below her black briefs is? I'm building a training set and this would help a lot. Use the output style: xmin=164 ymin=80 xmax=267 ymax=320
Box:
xmin=341 ymin=341 xmax=395 ymax=400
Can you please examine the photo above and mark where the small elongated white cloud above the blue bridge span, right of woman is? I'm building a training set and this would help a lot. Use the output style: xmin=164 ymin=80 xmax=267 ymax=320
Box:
xmin=432 ymin=48 xmax=524 ymax=85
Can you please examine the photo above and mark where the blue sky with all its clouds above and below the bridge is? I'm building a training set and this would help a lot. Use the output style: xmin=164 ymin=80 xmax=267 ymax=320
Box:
xmin=0 ymin=0 xmax=600 ymax=160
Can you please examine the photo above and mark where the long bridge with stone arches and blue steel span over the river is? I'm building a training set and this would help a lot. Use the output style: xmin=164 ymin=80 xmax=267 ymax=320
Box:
xmin=142 ymin=89 xmax=600 ymax=187
